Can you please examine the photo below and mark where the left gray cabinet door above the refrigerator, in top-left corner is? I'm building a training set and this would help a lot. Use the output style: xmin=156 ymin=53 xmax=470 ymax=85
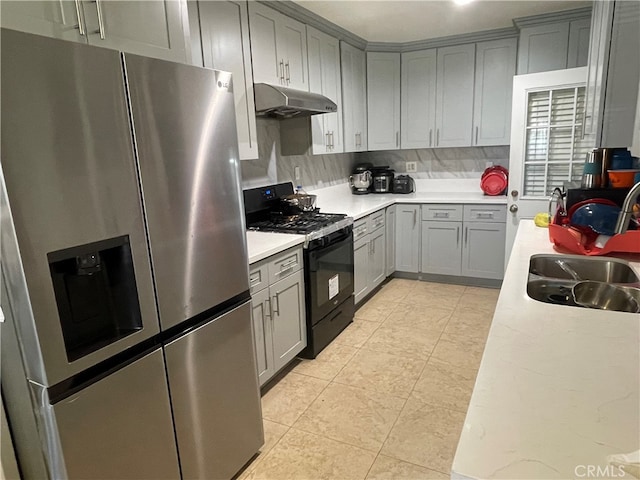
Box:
xmin=0 ymin=0 xmax=87 ymax=43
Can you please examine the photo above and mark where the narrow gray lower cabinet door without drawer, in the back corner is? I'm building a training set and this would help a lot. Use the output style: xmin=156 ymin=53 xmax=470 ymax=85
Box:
xmin=395 ymin=203 xmax=420 ymax=273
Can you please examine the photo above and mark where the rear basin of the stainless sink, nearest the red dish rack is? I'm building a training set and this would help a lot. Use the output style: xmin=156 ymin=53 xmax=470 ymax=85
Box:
xmin=529 ymin=255 xmax=640 ymax=283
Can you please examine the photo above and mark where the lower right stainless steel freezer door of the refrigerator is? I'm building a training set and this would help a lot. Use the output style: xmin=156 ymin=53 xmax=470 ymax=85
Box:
xmin=165 ymin=303 xmax=264 ymax=479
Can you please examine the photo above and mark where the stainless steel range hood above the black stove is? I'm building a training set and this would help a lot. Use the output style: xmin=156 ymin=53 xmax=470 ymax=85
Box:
xmin=253 ymin=83 xmax=338 ymax=119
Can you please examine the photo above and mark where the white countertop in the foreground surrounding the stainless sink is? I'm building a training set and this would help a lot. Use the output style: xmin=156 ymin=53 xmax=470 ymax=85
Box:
xmin=451 ymin=220 xmax=640 ymax=479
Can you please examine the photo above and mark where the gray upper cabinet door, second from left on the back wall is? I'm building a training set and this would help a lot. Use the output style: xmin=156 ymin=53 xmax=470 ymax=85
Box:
xmin=400 ymin=49 xmax=437 ymax=148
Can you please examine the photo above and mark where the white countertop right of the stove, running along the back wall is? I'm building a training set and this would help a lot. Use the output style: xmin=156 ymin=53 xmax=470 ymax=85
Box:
xmin=309 ymin=179 xmax=507 ymax=220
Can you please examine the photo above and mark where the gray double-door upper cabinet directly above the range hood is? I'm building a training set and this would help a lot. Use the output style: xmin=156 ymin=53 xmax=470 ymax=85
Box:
xmin=249 ymin=2 xmax=309 ymax=91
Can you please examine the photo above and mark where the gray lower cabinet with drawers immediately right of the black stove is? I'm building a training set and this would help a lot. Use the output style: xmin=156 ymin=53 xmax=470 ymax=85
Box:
xmin=353 ymin=209 xmax=387 ymax=304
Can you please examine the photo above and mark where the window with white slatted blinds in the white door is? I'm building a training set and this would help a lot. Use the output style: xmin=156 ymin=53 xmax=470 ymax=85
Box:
xmin=523 ymin=87 xmax=590 ymax=197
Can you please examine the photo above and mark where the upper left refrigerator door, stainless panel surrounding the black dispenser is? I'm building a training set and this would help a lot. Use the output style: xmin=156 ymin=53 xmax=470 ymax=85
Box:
xmin=0 ymin=29 xmax=159 ymax=386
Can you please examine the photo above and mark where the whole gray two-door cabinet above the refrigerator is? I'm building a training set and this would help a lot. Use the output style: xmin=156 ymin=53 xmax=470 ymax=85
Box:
xmin=1 ymin=0 xmax=190 ymax=63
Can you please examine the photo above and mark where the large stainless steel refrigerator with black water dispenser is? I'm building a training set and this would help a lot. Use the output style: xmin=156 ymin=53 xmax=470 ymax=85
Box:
xmin=0 ymin=29 xmax=263 ymax=479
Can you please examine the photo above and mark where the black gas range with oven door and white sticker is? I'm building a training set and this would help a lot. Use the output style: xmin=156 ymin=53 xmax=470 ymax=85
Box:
xmin=244 ymin=183 xmax=354 ymax=358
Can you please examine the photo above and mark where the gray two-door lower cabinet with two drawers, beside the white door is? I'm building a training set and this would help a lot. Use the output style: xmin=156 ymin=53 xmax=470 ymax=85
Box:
xmin=420 ymin=205 xmax=506 ymax=280
